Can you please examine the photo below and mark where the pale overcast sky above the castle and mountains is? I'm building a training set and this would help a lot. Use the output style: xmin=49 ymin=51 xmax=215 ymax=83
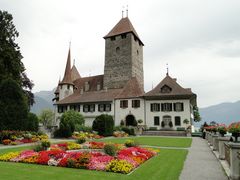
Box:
xmin=0 ymin=0 xmax=240 ymax=107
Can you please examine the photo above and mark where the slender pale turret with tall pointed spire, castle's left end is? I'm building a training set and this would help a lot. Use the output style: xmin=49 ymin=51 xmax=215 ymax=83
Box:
xmin=59 ymin=48 xmax=74 ymax=101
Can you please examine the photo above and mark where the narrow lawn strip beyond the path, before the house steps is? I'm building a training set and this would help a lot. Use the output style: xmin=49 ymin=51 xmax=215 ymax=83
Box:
xmin=96 ymin=137 xmax=192 ymax=147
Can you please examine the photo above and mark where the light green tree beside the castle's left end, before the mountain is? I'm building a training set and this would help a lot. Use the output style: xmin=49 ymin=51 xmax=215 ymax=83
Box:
xmin=39 ymin=109 xmax=54 ymax=127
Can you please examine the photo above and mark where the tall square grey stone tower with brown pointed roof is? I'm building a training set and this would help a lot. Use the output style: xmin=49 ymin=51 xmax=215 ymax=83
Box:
xmin=104 ymin=17 xmax=144 ymax=89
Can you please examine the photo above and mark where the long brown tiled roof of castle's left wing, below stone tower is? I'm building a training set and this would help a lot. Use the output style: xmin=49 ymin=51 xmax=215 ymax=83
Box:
xmin=56 ymin=75 xmax=144 ymax=104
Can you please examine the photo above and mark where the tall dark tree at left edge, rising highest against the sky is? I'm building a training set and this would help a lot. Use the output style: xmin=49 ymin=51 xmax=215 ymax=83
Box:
xmin=0 ymin=10 xmax=34 ymax=107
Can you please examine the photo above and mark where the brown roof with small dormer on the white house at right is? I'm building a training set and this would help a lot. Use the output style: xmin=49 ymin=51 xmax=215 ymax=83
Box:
xmin=144 ymin=74 xmax=196 ymax=98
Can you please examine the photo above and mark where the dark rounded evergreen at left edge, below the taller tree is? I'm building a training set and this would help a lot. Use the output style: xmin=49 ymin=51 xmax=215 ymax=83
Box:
xmin=0 ymin=78 xmax=28 ymax=130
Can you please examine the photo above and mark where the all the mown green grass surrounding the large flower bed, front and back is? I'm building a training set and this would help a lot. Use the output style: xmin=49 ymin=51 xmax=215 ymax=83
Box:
xmin=0 ymin=137 xmax=191 ymax=180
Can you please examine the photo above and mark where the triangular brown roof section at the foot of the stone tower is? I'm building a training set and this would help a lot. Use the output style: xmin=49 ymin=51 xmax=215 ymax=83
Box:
xmin=116 ymin=77 xmax=144 ymax=99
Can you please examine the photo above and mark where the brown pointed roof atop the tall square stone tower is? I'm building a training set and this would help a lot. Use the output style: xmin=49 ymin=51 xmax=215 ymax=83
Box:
xmin=103 ymin=17 xmax=144 ymax=45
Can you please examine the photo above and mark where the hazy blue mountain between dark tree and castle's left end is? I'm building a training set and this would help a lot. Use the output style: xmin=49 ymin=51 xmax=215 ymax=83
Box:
xmin=31 ymin=90 xmax=54 ymax=114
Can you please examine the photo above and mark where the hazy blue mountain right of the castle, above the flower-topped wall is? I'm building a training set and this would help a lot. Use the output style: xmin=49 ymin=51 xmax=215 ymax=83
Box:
xmin=196 ymin=101 xmax=240 ymax=126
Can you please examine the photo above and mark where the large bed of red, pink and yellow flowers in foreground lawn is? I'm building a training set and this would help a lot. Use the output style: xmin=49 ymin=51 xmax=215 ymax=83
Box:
xmin=0 ymin=142 xmax=157 ymax=174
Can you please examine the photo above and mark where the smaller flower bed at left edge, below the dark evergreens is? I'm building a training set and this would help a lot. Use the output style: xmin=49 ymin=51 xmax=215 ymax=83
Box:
xmin=0 ymin=131 xmax=48 ymax=145
